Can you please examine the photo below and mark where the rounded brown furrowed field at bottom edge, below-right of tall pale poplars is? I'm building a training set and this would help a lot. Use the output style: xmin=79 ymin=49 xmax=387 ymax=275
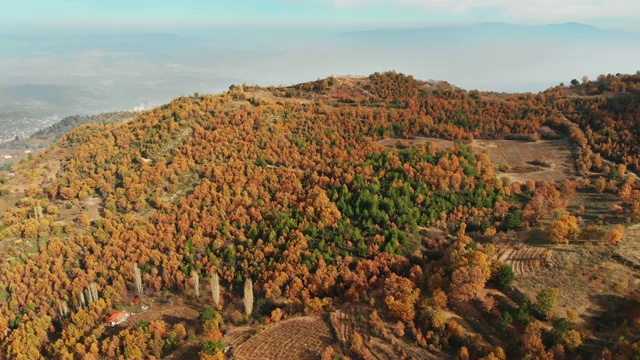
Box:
xmin=234 ymin=316 xmax=335 ymax=360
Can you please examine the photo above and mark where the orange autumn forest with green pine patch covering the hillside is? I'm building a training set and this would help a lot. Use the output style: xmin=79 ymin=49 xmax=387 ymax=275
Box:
xmin=0 ymin=72 xmax=640 ymax=359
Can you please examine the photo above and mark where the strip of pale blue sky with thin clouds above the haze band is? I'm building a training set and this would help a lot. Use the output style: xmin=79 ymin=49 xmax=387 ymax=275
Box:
xmin=0 ymin=0 xmax=640 ymax=30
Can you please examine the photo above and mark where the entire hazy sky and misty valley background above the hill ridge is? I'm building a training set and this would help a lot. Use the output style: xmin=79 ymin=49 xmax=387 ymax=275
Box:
xmin=0 ymin=0 xmax=640 ymax=138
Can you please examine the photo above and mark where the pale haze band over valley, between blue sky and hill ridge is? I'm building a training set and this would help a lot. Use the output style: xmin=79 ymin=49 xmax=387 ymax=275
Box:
xmin=0 ymin=23 xmax=640 ymax=140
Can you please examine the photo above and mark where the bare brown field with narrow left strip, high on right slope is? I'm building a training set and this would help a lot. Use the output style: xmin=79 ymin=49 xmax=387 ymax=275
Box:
xmin=378 ymin=137 xmax=576 ymax=182
